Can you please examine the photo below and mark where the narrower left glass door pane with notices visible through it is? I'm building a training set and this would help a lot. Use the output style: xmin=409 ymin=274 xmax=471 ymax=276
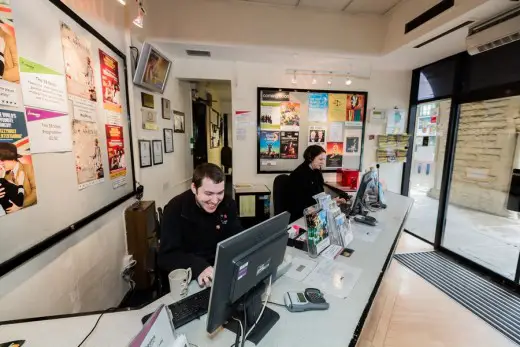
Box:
xmin=405 ymin=99 xmax=451 ymax=243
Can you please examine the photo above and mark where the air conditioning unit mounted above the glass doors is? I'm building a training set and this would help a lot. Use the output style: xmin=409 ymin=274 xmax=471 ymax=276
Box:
xmin=466 ymin=6 xmax=520 ymax=55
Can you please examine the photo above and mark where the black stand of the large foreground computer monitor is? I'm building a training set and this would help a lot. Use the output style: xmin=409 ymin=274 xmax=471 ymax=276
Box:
xmin=224 ymin=286 xmax=280 ymax=345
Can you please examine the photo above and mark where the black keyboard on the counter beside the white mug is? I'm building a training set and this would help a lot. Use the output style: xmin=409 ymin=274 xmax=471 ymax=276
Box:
xmin=142 ymin=288 xmax=211 ymax=329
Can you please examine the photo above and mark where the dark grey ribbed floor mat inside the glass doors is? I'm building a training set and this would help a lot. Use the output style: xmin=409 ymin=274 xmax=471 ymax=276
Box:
xmin=394 ymin=252 xmax=520 ymax=345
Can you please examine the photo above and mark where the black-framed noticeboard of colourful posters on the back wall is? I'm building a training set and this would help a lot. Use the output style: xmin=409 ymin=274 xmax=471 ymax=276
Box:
xmin=257 ymin=87 xmax=368 ymax=174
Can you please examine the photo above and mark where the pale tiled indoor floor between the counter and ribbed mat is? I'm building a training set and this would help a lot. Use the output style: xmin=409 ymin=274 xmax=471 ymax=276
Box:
xmin=357 ymin=234 xmax=517 ymax=347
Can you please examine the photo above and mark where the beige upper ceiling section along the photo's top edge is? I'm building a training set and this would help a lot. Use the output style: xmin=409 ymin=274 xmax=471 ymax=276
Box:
xmin=230 ymin=0 xmax=403 ymax=15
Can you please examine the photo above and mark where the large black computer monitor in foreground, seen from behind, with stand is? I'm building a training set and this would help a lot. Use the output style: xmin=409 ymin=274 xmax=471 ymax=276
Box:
xmin=206 ymin=212 xmax=290 ymax=344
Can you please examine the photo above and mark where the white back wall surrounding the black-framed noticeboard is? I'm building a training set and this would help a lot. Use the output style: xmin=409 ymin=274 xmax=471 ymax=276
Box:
xmin=173 ymin=59 xmax=411 ymax=197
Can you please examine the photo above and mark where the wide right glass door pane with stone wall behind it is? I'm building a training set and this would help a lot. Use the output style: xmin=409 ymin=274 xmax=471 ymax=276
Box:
xmin=442 ymin=96 xmax=520 ymax=279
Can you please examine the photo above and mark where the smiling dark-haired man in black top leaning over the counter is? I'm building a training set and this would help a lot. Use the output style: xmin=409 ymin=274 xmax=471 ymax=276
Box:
xmin=159 ymin=163 xmax=243 ymax=286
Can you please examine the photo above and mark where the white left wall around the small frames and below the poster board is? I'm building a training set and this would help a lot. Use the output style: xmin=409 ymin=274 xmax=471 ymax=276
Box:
xmin=0 ymin=0 xmax=192 ymax=321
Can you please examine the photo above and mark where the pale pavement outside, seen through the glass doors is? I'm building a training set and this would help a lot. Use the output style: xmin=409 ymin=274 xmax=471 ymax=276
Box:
xmin=405 ymin=185 xmax=520 ymax=279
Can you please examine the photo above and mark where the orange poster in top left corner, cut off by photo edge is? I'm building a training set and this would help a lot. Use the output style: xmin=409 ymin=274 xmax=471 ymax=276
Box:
xmin=0 ymin=0 xmax=22 ymax=107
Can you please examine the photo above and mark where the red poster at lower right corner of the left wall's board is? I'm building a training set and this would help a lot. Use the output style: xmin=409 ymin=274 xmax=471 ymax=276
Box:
xmin=105 ymin=124 xmax=126 ymax=189
